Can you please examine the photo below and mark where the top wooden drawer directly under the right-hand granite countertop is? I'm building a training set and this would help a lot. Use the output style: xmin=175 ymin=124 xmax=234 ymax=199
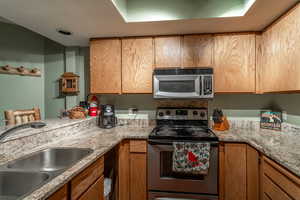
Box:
xmin=263 ymin=157 xmax=300 ymax=199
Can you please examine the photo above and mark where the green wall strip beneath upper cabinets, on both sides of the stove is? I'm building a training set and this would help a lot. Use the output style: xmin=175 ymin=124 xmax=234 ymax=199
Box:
xmin=100 ymin=94 xmax=300 ymax=125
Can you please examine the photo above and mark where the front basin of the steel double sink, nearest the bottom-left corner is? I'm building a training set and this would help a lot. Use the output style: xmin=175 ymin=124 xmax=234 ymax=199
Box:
xmin=0 ymin=171 xmax=50 ymax=200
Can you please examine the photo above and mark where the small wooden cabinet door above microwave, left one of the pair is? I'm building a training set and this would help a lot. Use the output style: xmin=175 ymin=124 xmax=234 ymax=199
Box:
xmin=154 ymin=36 xmax=181 ymax=68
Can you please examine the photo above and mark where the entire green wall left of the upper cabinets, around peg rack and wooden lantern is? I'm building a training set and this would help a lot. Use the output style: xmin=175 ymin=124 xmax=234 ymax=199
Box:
xmin=0 ymin=23 xmax=89 ymax=122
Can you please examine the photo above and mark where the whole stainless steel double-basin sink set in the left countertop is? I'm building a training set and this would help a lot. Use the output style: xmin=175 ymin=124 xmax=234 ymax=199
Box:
xmin=0 ymin=148 xmax=93 ymax=200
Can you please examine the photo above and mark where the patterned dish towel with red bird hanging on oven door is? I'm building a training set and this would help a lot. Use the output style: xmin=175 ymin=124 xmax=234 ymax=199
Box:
xmin=172 ymin=142 xmax=210 ymax=175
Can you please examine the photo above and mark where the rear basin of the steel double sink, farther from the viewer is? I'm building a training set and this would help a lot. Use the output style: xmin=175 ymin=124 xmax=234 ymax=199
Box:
xmin=7 ymin=148 xmax=92 ymax=172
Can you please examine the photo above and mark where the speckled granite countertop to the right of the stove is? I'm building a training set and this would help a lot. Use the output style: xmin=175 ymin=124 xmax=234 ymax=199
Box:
xmin=214 ymin=129 xmax=300 ymax=177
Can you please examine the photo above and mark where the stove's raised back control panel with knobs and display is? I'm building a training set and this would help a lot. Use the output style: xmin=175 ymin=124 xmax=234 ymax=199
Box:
xmin=156 ymin=108 xmax=208 ymax=120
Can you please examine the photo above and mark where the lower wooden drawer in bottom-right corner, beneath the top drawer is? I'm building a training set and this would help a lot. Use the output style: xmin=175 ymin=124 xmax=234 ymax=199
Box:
xmin=263 ymin=176 xmax=292 ymax=200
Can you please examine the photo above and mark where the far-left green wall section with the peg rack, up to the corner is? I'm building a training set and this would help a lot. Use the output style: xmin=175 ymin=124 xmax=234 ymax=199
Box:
xmin=0 ymin=23 xmax=45 ymax=125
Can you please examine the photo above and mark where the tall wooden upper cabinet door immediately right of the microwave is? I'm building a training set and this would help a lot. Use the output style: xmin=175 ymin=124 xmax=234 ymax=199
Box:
xmin=213 ymin=34 xmax=256 ymax=93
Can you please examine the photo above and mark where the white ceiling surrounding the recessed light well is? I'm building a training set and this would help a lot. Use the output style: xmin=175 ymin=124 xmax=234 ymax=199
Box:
xmin=0 ymin=0 xmax=298 ymax=46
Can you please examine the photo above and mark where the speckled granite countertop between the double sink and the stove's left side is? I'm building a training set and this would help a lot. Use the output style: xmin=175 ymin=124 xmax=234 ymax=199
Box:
xmin=20 ymin=126 xmax=153 ymax=200
